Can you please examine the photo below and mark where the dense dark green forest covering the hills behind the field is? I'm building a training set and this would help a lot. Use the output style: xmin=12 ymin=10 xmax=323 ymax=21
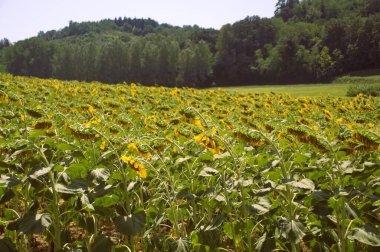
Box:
xmin=0 ymin=0 xmax=380 ymax=87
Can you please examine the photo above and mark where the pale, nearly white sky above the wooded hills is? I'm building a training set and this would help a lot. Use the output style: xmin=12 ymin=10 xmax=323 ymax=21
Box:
xmin=0 ymin=0 xmax=277 ymax=42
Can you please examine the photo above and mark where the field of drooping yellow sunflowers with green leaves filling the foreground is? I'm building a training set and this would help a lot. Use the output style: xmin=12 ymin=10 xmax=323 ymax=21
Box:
xmin=0 ymin=74 xmax=380 ymax=252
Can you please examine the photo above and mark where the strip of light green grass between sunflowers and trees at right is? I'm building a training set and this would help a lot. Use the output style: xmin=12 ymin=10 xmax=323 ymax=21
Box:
xmin=226 ymin=75 xmax=380 ymax=97
